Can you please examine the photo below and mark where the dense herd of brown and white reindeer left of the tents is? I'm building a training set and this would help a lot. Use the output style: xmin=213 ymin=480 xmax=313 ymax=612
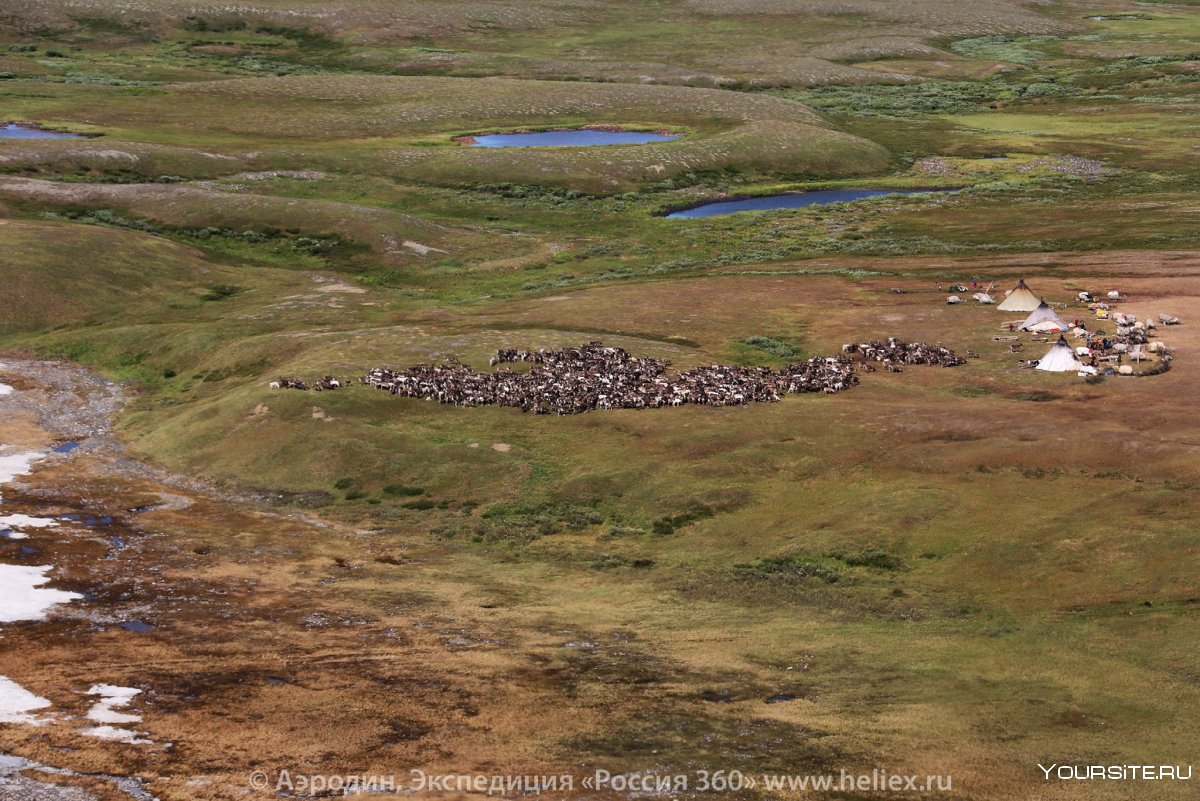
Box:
xmin=271 ymin=338 xmax=964 ymax=415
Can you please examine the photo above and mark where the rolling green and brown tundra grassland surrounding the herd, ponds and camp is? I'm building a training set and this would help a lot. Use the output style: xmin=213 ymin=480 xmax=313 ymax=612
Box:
xmin=0 ymin=0 xmax=1200 ymax=801
